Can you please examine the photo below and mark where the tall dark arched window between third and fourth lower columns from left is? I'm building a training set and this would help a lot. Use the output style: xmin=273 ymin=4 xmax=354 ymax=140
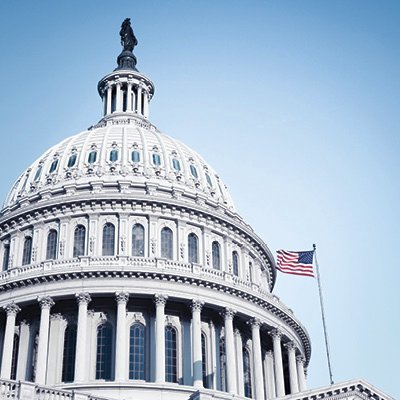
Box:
xmin=96 ymin=322 xmax=113 ymax=380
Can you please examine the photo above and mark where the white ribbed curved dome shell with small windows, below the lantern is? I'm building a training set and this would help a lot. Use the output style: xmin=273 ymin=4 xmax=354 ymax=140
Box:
xmin=3 ymin=118 xmax=234 ymax=211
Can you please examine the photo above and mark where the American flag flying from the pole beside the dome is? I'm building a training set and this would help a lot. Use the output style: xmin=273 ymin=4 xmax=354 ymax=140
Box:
xmin=277 ymin=250 xmax=315 ymax=277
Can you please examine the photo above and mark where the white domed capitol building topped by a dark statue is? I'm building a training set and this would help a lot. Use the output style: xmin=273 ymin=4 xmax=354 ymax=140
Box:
xmin=0 ymin=20 xmax=390 ymax=400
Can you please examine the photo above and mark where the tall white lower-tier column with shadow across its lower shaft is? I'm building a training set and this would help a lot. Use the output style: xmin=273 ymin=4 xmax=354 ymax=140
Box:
xmin=191 ymin=299 xmax=204 ymax=388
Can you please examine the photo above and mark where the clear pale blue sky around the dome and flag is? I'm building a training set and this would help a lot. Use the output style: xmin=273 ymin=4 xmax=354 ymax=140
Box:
xmin=0 ymin=0 xmax=400 ymax=397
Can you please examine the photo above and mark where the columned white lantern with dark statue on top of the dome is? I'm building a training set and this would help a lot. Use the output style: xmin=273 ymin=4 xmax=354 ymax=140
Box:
xmin=97 ymin=18 xmax=154 ymax=120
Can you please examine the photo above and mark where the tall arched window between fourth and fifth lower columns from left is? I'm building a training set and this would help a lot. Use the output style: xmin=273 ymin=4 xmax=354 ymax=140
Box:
xmin=129 ymin=322 xmax=146 ymax=381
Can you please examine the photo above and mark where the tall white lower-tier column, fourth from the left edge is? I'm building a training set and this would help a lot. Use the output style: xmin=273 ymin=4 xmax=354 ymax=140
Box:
xmin=115 ymin=292 xmax=129 ymax=381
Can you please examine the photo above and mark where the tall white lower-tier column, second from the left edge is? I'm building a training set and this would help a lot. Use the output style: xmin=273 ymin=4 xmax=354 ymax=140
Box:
xmin=35 ymin=296 xmax=54 ymax=385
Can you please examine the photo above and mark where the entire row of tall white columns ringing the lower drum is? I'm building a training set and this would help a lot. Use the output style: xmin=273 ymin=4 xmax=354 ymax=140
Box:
xmin=0 ymin=292 xmax=306 ymax=400
